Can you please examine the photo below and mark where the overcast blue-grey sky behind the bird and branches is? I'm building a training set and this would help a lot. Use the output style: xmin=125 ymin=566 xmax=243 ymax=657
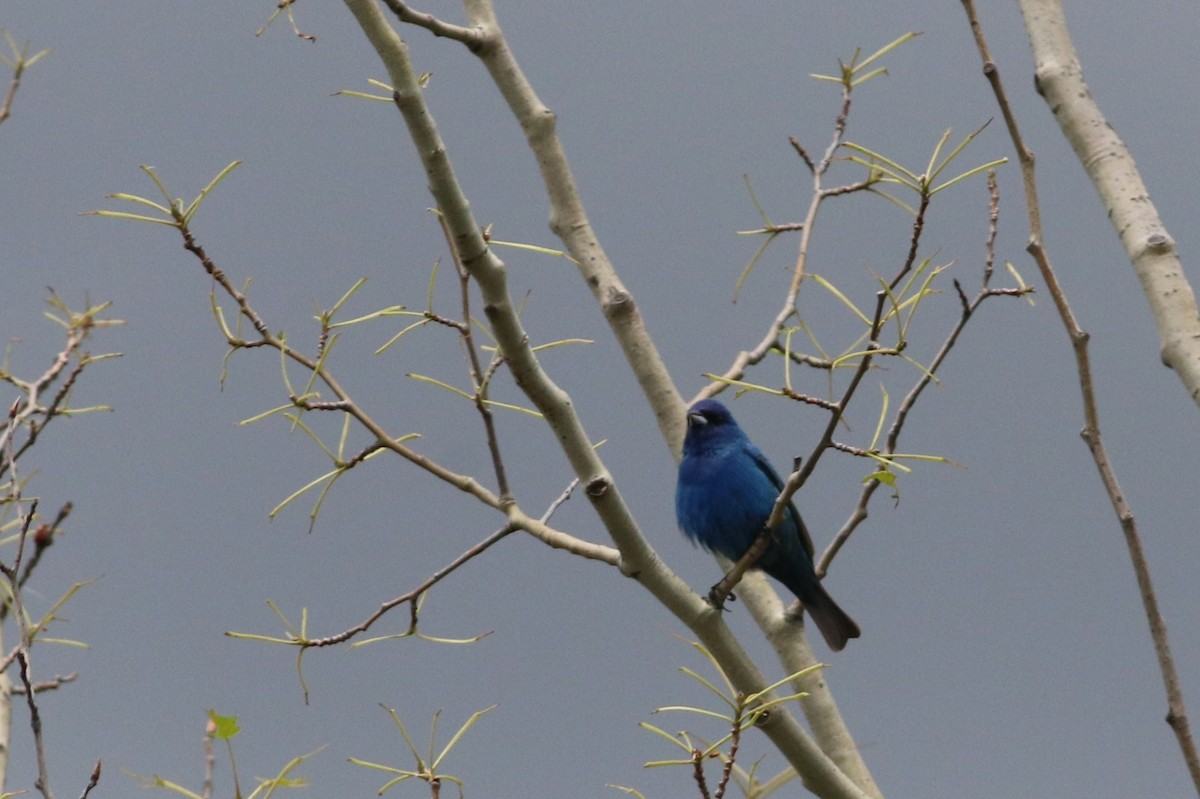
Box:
xmin=0 ymin=0 xmax=1200 ymax=799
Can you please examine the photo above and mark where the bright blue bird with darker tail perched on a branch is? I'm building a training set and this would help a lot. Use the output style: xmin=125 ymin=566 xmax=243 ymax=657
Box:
xmin=676 ymin=400 xmax=860 ymax=651
